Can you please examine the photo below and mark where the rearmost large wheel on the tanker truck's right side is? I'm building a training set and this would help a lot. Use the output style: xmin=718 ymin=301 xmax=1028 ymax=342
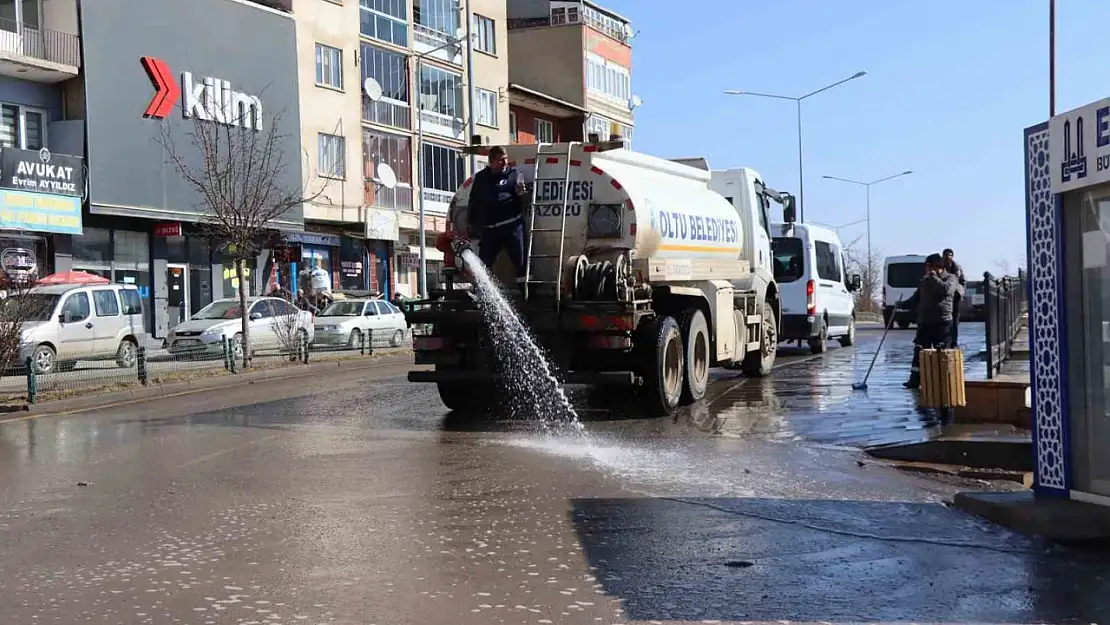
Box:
xmin=636 ymin=316 xmax=685 ymax=416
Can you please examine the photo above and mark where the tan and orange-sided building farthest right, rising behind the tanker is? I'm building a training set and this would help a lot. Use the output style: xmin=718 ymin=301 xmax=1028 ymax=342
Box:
xmin=507 ymin=0 xmax=638 ymax=142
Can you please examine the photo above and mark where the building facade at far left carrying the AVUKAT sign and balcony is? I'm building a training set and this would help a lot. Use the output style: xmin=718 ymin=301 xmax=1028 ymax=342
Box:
xmin=0 ymin=0 xmax=85 ymax=295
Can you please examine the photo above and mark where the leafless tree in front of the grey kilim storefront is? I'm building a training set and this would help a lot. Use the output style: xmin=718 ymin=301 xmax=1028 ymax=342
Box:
xmin=161 ymin=102 xmax=327 ymax=369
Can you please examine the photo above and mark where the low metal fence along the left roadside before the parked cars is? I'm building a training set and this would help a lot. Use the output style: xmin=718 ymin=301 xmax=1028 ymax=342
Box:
xmin=0 ymin=331 xmax=412 ymax=404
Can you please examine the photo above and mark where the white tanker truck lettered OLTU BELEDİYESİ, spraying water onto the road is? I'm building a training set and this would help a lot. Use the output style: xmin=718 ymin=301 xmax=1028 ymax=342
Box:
xmin=405 ymin=141 xmax=795 ymax=415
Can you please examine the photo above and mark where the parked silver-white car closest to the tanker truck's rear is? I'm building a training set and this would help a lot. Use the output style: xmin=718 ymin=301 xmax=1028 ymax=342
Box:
xmin=315 ymin=300 xmax=408 ymax=347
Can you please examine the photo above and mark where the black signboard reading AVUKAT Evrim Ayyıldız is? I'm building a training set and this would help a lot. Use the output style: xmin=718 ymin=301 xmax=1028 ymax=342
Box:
xmin=0 ymin=148 xmax=84 ymax=198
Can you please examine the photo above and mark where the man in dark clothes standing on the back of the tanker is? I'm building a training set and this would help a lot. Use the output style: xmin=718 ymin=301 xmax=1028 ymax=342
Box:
xmin=466 ymin=145 xmax=525 ymax=284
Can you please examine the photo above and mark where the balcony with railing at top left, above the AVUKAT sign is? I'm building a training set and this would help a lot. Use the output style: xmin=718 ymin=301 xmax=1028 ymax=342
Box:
xmin=0 ymin=18 xmax=81 ymax=83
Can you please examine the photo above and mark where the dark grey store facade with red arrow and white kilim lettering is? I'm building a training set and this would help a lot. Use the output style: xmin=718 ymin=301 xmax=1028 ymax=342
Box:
xmin=72 ymin=0 xmax=303 ymax=337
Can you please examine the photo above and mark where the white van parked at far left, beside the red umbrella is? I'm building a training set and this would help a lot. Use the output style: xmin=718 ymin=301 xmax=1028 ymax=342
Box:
xmin=9 ymin=284 xmax=147 ymax=374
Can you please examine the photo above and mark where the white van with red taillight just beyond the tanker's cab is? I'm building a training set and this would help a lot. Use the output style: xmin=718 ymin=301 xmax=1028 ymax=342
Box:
xmin=770 ymin=223 xmax=860 ymax=354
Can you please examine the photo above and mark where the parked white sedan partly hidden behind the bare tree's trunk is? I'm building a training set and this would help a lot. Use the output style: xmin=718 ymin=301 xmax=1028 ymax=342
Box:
xmin=165 ymin=298 xmax=315 ymax=357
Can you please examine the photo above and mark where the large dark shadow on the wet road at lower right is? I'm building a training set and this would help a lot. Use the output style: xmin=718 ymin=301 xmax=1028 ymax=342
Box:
xmin=571 ymin=498 xmax=1110 ymax=623
